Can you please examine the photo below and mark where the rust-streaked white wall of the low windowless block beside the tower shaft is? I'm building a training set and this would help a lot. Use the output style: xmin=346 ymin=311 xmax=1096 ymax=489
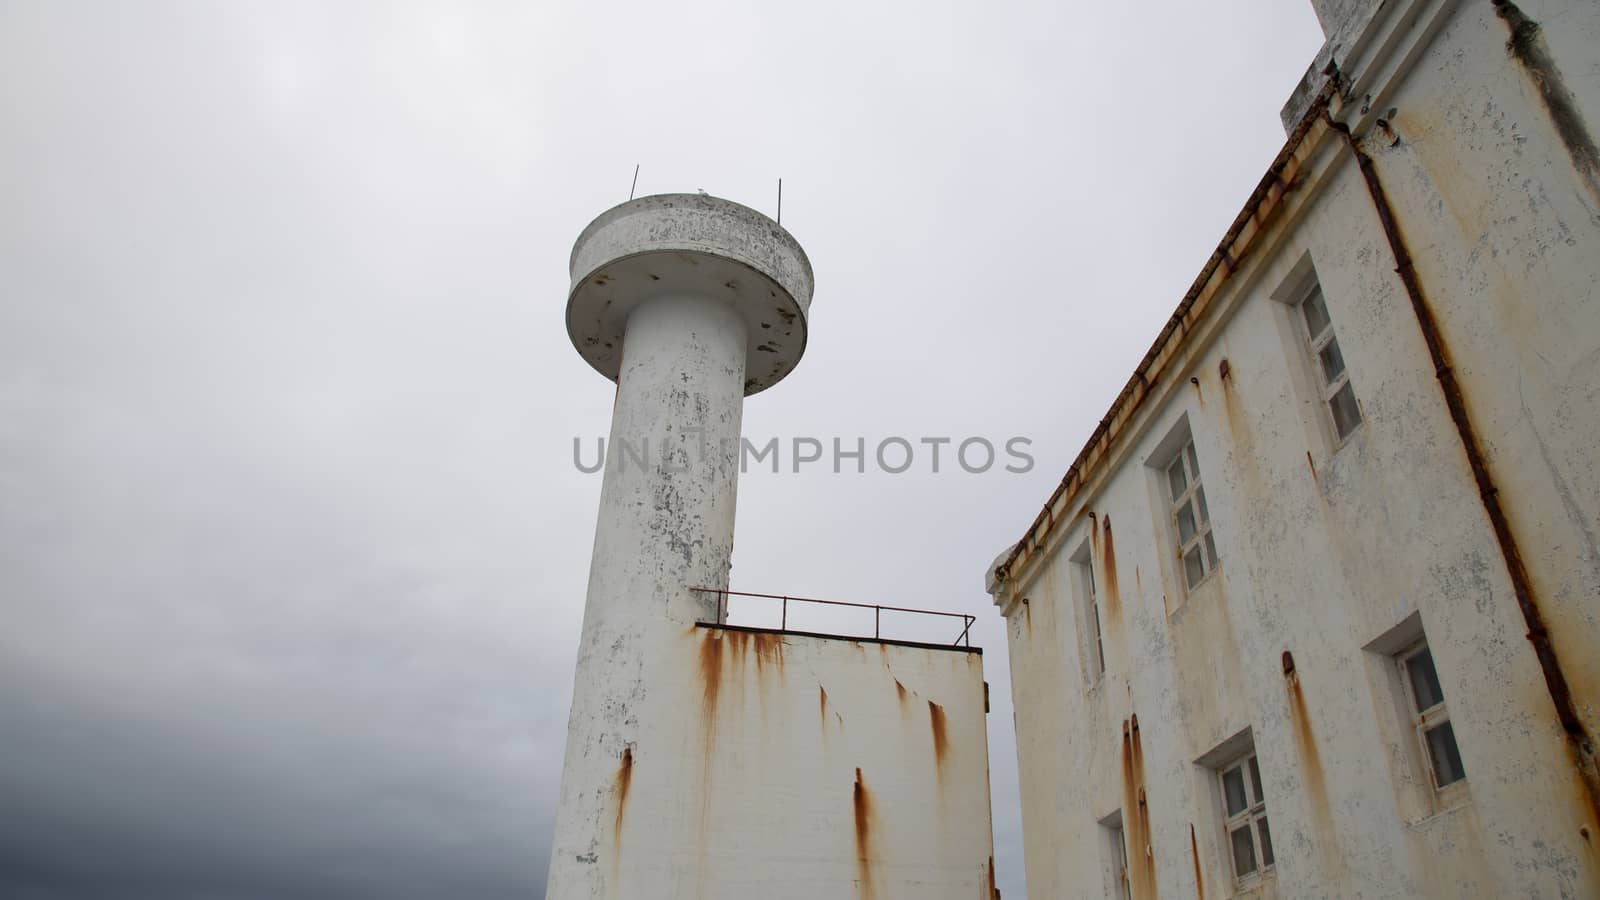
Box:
xmin=574 ymin=628 xmax=994 ymax=900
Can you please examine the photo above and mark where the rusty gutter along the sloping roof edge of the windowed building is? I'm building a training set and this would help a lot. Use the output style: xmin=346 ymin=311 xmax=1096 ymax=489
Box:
xmin=995 ymin=78 xmax=1338 ymax=580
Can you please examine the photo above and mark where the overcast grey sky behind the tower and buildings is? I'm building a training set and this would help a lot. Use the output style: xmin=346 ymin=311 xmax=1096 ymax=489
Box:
xmin=0 ymin=0 xmax=1320 ymax=900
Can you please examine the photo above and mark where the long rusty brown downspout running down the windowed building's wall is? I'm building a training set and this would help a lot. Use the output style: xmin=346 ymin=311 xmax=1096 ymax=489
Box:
xmin=1323 ymin=110 xmax=1600 ymax=822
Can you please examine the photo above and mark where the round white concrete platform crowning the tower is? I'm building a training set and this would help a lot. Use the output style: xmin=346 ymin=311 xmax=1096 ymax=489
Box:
xmin=566 ymin=194 xmax=814 ymax=396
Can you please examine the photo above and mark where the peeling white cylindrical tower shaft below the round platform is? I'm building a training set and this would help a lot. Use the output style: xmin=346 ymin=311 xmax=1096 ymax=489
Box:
xmin=547 ymin=295 xmax=746 ymax=898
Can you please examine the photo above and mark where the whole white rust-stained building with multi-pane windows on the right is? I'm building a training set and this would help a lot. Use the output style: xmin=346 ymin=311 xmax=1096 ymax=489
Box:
xmin=987 ymin=0 xmax=1600 ymax=900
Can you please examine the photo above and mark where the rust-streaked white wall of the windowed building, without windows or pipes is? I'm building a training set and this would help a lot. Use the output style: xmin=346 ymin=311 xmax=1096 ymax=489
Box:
xmin=998 ymin=0 xmax=1600 ymax=898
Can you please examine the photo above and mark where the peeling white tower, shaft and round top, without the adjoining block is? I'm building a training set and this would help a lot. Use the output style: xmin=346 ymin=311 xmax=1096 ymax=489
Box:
xmin=547 ymin=195 xmax=811 ymax=900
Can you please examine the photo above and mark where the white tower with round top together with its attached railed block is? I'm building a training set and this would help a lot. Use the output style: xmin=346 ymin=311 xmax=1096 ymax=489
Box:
xmin=546 ymin=194 xmax=994 ymax=900
